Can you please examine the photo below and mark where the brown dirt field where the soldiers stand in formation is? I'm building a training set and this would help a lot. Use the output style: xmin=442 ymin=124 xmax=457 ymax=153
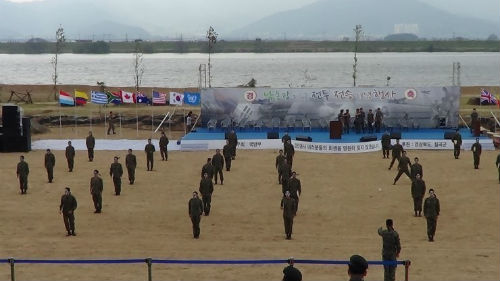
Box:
xmin=0 ymin=145 xmax=500 ymax=280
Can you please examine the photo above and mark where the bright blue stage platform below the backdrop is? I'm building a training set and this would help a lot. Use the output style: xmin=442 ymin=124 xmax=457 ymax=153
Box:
xmin=182 ymin=128 xmax=489 ymax=143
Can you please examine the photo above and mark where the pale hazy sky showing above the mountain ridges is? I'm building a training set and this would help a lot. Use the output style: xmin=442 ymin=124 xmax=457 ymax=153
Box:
xmin=8 ymin=0 xmax=500 ymax=22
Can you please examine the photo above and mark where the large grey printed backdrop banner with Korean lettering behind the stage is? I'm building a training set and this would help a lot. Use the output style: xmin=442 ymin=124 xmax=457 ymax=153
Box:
xmin=201 ymin=87 xmax=460 ymax=128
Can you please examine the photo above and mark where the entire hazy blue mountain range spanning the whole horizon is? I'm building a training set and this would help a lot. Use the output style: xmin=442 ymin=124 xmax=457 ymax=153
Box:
xmin=0 ymin=0 xmax=499 ymax=41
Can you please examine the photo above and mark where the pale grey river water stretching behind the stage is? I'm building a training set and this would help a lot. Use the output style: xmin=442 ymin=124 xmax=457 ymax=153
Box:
xmin=0 ymin=53 xmax=500 ymax=88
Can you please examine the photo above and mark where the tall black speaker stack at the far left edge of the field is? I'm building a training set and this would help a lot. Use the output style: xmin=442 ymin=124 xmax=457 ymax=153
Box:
xmin=0 ymin=105 xmax=31 ymax=152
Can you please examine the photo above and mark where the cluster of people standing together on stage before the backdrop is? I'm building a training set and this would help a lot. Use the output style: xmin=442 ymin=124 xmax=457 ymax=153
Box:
xmin=337 ymin=107 xmax=384 ymax=134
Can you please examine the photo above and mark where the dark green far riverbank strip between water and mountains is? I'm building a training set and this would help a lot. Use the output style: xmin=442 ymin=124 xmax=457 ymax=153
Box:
xmin=0 ymin=39 xmax=500 ymax=54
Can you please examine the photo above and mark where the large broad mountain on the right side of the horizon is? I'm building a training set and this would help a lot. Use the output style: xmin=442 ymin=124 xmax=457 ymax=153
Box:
xmin=230 ymin=0 xmax=499 ymax=39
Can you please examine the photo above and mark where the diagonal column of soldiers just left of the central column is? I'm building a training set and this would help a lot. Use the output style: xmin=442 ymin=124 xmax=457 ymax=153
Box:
xmin=188 ymin=131 xmax=238 ymax=239
